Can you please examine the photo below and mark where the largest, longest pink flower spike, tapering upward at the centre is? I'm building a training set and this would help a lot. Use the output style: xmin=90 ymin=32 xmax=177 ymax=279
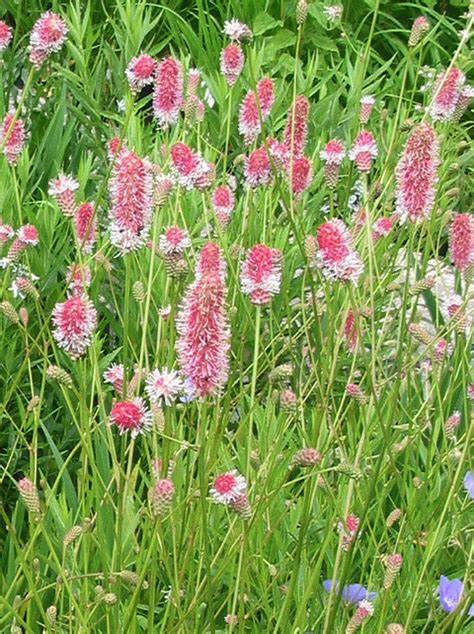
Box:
xmin=176 ymin=242 xmax=230 ymax=397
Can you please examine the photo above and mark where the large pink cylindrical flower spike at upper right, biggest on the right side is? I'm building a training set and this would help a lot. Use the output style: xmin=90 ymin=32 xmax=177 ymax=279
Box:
xmin=395 ymin=123 xmax=439 ymax=222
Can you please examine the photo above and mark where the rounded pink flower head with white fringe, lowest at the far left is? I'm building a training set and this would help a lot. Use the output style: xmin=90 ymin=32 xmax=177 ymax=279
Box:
xmin=53 ymin=294 xmax=97 ymax=359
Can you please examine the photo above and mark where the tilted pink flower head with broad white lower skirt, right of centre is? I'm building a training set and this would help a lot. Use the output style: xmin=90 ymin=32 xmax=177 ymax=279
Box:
xmin=316 ymin=218 xmax=364 ymax=284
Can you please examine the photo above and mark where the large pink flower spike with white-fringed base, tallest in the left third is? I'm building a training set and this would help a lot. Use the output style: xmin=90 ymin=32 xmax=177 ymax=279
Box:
xmin=109 ymin=150 xmax=153 ymax=254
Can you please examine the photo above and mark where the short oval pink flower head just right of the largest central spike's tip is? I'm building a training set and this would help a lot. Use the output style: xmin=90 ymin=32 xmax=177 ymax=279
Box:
xmin=240 ymin=244 xmax=282 ymax=305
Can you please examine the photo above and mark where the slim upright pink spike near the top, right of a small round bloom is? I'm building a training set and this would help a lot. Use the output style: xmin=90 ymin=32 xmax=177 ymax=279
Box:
xmin=153 ymin=57 xmax=184 ymax=129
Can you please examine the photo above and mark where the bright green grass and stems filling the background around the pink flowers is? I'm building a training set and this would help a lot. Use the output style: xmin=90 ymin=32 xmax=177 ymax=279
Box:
xmin=0 ymin=0 xmax=473 ymax=633
